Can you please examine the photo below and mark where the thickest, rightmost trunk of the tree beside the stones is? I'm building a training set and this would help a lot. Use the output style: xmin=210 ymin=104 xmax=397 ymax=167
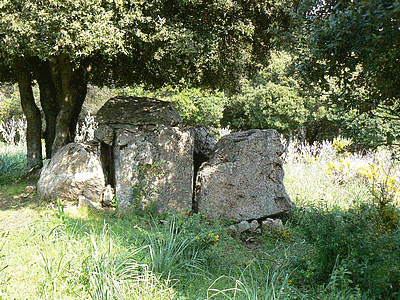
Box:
xmin=52 ymin=55 xmax=88 ymax=155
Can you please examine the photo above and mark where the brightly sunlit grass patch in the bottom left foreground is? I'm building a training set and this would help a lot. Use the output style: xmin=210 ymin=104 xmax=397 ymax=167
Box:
xmin=0 ymin=204 xmax=175 ymax=299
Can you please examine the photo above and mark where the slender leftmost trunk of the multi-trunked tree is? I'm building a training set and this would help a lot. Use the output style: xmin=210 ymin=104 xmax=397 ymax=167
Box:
xmin=15 ymin=60 xmax=43 ymax=172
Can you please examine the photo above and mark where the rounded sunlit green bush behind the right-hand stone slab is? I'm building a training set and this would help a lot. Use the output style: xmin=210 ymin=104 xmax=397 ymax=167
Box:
xmin=222 ymin=53 xmax=309 ymax=133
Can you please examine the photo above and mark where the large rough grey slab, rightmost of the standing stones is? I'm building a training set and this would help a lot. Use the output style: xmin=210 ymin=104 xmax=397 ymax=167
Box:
xmin=195 ymin=130 xmax=292 ymax=222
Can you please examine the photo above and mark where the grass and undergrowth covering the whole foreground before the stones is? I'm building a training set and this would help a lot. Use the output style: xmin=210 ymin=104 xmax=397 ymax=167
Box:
xmin=0 ymin=142 xmax=400 ymax=300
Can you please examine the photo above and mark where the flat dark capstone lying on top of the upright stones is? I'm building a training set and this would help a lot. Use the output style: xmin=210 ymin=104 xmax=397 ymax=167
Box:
xmin=96 ymin=97 xmax=182 ymax=126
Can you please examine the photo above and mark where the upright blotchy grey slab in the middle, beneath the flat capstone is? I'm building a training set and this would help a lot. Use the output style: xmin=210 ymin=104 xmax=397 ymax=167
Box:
xmin=114 ymin=125 xmax=193 ymax=213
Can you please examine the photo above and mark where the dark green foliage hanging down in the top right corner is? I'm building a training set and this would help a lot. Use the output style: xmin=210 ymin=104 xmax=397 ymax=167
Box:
xmin=295 ymin=0 xmax=400 ymax=146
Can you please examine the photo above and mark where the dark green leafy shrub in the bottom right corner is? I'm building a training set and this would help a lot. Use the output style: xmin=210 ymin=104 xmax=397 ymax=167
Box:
xmin=292 ymin=204 xmax=400 ymax=299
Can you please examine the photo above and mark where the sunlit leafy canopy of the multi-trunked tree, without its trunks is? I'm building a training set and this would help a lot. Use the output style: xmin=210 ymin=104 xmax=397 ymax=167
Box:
xmin=0 ymin=0 xmax=290 ymax=86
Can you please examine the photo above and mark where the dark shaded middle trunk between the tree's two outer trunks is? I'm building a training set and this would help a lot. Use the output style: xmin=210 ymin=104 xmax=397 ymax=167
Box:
xmin=32 ymin=59 xmax=60 ymax=158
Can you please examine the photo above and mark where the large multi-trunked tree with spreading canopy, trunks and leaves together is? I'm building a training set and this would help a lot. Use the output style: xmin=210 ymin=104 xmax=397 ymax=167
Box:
xmin=0 ymin=0 xmax=291 ymax=168
